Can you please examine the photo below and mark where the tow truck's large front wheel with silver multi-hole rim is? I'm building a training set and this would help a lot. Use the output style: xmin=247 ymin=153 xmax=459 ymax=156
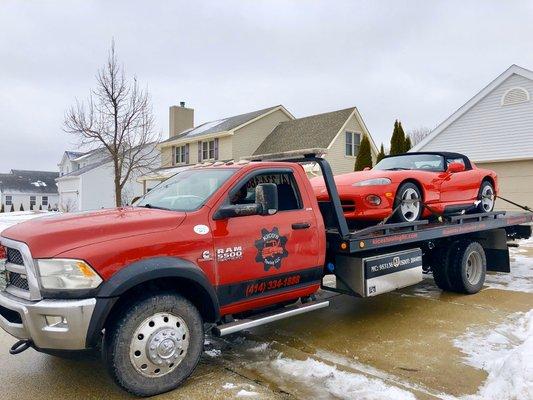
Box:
xmin=104 ymin=293 xmax=204 ymax=396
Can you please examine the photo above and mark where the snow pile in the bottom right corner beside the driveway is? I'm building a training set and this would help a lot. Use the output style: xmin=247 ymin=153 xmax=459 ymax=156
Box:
xmin=454 ymin=310 xmax=533 ymax=400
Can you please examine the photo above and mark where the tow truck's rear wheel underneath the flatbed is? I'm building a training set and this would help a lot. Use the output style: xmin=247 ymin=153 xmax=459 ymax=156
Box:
xmin=447 ymin=240 xmax=487 ymax=294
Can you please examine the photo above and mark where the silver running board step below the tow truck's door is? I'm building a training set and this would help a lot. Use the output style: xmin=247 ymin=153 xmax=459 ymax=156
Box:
xmin=213 ymin=300 xmax=329 ymax=336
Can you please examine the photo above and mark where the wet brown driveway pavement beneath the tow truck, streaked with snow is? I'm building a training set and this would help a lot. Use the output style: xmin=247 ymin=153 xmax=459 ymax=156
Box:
xmin=0 ymin=242 xmax=533 ymax=400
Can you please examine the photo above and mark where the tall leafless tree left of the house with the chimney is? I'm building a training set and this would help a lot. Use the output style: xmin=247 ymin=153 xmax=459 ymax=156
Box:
xmin=64 ymin=41 xmax=159 ymax=207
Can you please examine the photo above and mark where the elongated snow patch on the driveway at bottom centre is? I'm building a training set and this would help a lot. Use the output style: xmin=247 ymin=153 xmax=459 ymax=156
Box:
xmin=270 ymin=356 xmax=415 ymax=400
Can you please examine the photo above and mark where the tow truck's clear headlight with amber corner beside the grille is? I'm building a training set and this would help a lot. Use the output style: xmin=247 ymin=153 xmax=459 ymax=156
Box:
xmin=35 ymin=259 xmax=102 ymax=290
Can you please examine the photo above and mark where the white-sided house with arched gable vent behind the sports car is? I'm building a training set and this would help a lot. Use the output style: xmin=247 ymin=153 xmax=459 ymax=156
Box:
xmin=411 ymin=65 xmax=533 ymax=210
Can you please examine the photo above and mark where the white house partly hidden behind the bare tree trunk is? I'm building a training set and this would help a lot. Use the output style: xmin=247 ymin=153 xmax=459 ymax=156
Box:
xmin=56 ymin=145 xmax=161 ymax=211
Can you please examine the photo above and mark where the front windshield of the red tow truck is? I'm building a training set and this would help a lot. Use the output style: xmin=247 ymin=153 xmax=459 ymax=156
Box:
xmin=133 ymin=168 xmax=235 ymax=211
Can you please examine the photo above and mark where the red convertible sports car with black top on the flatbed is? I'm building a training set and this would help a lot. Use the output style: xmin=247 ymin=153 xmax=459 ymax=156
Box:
xmin=311 ymin=152 xmax=498 ymax=222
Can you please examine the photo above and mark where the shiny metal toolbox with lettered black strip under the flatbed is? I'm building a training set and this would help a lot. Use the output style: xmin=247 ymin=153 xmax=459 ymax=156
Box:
xmin=335 ymin=248 xmax=422 ymax=297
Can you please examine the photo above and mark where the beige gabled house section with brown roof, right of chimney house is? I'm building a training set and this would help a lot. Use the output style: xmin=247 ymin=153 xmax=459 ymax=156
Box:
xmin=254 ymin=107 xmax=379 ymax=174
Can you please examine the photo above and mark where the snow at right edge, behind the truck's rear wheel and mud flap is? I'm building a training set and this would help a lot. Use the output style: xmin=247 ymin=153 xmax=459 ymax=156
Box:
xmin=485 ymin=238 xmax=533 ymax=293
